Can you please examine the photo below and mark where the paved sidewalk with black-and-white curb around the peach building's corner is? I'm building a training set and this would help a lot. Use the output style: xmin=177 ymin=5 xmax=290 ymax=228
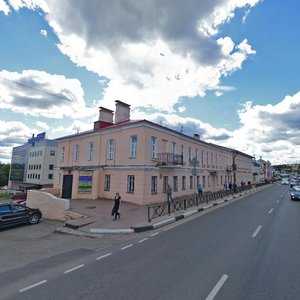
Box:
xmin=56 ymin=186 xmax=267 ymax=237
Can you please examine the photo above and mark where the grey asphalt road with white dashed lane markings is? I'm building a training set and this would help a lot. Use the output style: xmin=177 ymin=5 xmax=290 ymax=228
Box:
xmin=0 ymin=184 xmax=300 ymax=300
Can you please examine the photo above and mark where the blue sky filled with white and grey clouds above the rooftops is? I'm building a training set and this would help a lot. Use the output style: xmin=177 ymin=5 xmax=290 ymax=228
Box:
xmin=0 ymin=0 xmax=300 ymax=165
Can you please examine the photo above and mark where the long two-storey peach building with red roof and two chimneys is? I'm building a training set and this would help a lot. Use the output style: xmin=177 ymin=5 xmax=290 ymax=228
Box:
xmin=54 ymin=100 xmax=253 ymax=204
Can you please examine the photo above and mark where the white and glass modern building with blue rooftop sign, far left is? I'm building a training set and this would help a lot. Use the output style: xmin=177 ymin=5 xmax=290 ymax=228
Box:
xmin=9 ymin=133 xmax=57 ymax=190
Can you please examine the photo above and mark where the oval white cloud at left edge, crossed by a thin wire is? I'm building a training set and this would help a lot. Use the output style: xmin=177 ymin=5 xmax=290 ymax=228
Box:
xmin=0 ymin=70 xmax=95 ymax=119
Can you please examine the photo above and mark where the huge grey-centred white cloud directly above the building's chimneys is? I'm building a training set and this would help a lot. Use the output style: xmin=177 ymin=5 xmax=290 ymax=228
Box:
xmin=7 ymin=0 xmax=259 ymax=111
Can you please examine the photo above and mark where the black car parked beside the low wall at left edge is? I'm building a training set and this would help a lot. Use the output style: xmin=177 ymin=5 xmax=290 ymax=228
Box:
xmin=0 ymin=203 xmax=42 ymax=228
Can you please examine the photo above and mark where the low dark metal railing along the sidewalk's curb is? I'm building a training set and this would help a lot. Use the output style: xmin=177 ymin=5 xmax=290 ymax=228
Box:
xmin=148 ymin=183 xmax=266 ymax=222
